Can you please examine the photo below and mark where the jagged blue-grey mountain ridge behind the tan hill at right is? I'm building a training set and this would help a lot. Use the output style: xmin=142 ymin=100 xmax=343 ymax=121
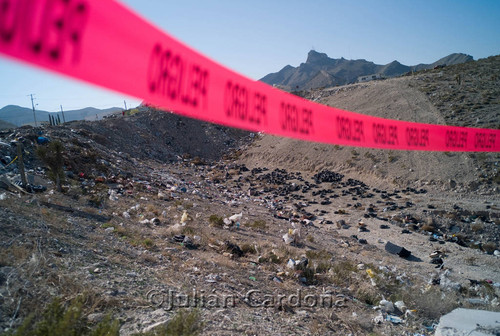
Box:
xmin=260 ymin=50 xmax=474 ymax=91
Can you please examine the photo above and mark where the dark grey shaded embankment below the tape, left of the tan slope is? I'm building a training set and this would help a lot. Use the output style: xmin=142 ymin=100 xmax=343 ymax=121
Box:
xmin=68 ymin=108 xmax=249 ymax=162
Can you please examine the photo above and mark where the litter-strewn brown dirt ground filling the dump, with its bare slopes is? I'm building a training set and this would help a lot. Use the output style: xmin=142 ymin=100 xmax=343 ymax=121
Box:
xmin=0 ymin=56 xmax=500 ymax=335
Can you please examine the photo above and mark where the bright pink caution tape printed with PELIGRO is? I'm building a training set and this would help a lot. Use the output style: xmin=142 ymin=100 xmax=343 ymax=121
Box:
xmin=0 ymin=0 xmax=500 ymax=152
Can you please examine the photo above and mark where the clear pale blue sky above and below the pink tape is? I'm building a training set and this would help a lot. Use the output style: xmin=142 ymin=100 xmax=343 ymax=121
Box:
xmin=0 ymin=0 xmax=500 ymax=111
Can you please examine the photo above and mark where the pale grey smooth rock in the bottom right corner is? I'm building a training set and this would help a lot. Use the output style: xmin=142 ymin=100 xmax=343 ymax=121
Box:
xmin=434 ymin=308 xmax=500 ymax=336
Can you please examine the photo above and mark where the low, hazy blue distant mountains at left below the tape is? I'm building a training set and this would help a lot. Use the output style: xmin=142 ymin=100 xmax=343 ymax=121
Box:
xmin=0 ymin=105 xmax=123 ymax=126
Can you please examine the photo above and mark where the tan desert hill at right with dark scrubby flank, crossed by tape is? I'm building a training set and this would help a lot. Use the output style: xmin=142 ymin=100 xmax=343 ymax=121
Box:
xmin=241 ymin=56 xmax=500 ymax=194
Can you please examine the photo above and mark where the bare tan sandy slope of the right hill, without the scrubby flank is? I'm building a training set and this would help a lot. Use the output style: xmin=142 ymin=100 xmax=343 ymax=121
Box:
xmin=241 ymin=75 xmax=498 ymax=195
